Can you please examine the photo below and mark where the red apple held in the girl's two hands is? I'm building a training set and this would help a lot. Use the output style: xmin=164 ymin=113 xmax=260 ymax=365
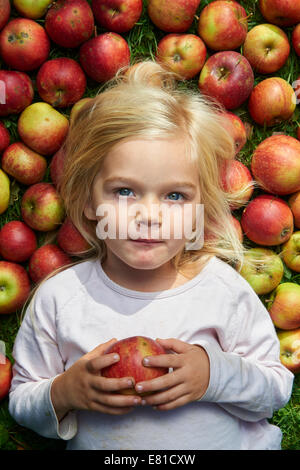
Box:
xmin=101 ymin=336 xmax=169 ymax=396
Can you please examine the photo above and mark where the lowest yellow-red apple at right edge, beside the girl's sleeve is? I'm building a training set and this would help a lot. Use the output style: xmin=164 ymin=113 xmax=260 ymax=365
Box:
xmin=277 ymin=328 xmax=300 ymax=374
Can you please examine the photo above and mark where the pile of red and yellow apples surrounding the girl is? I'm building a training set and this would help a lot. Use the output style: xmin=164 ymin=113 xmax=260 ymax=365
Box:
xmin=0 ymin=0 xmax=300 ymax=402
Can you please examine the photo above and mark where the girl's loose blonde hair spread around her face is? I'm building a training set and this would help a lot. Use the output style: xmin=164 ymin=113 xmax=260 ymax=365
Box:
xmin=21 ymin=60 xmax=253 ymax=320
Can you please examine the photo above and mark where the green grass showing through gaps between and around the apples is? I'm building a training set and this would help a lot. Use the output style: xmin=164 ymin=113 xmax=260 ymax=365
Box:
xmin=0 ymin=0 xmax=300 ymax=450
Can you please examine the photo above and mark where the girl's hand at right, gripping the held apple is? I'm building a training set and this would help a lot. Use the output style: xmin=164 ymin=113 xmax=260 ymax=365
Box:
xmin=135 ymin=338 xmax=209 ymax=410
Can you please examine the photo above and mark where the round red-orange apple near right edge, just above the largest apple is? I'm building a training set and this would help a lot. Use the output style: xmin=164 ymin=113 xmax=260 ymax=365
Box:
xmin=248 ymin=77 xmax=296 ymax=126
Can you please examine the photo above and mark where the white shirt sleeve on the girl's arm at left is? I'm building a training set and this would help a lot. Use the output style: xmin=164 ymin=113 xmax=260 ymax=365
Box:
xmin=9 ymin=282 xmax=77 ymax=440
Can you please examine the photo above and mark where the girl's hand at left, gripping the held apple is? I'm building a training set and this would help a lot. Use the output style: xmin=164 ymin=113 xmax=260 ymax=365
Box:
xmin=51 ymin=338 xmax=141 ymax=420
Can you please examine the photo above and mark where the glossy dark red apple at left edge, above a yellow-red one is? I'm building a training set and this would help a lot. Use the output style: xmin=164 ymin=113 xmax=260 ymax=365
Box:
xmin=0 ymin=220 xmax=37 ymax=263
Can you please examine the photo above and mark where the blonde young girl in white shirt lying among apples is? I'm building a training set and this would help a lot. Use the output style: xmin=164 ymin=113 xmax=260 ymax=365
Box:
xmin=9 ymin=61 xmax=293 ymax=450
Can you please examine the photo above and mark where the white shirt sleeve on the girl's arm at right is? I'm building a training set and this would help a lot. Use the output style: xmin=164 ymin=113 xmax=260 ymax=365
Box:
xmin=199 ymin=281 xmax=294 ymax=422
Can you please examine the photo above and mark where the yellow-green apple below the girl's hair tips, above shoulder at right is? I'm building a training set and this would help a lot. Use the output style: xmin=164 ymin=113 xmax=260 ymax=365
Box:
xmin=240 ymin=247 xmax=284 ymax=295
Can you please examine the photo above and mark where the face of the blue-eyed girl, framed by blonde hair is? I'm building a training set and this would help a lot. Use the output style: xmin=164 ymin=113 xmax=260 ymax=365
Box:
xmin=84 ymin=138 xmax=200 ymax=269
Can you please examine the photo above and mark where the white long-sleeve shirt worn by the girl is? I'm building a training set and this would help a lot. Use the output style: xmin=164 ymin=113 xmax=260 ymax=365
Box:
xmin=9 ymin=257 xmax=294 ymax=450
